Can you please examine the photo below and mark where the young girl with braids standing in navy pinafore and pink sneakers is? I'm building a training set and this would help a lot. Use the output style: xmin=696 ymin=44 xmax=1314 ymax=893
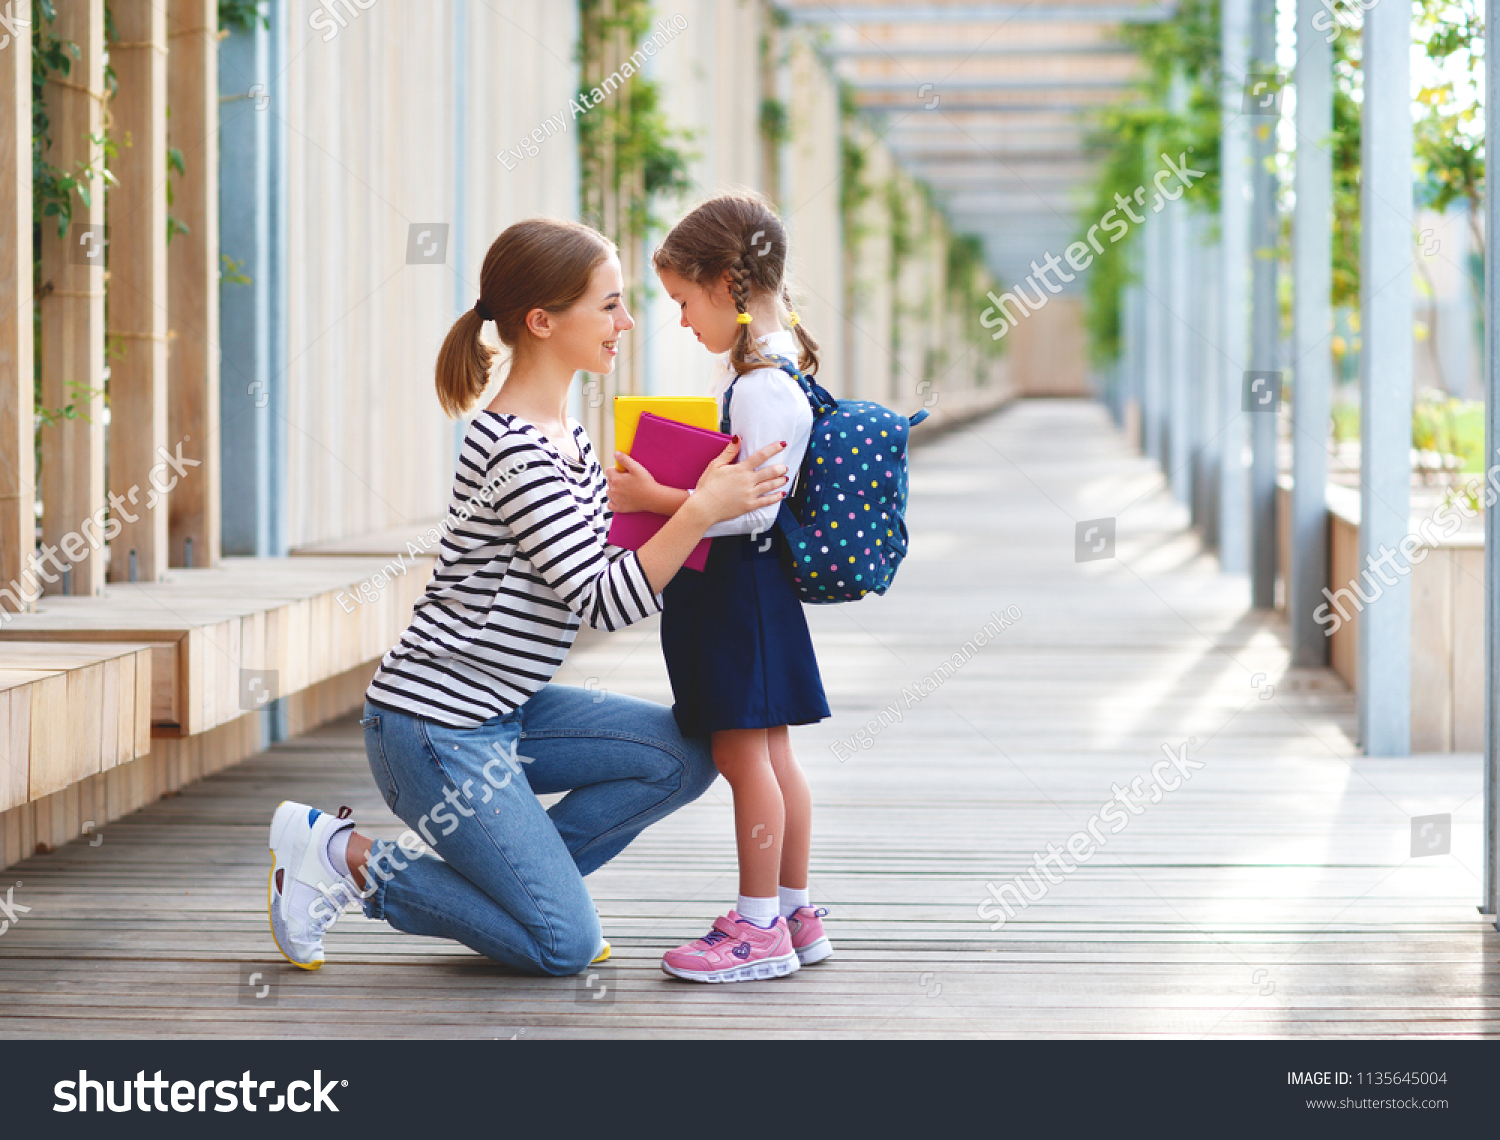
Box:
xmin=608 ymin=194 xmax=833 ymax=981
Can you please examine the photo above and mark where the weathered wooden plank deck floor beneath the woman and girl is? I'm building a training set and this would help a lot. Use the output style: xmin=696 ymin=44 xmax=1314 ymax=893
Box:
xmin=0 ymin=402 xmax=1500 ymax=1040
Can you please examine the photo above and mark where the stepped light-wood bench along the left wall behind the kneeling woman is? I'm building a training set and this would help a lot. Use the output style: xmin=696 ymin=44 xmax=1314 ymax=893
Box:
xmin=0 ymin=555 xmax=434 ymax=866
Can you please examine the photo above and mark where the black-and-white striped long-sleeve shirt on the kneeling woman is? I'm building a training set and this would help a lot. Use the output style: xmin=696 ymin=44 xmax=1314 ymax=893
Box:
xmin=366 ymin=411 xmax=662 ymax=728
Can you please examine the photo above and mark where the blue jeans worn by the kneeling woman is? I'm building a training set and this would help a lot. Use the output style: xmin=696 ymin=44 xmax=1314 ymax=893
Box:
xmin=360 ymin=684 xmax=717 ymax=975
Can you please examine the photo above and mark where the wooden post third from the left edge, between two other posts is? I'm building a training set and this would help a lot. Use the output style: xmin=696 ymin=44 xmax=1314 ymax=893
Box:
xmin=110 ymin=0 xmax=171 ymax=582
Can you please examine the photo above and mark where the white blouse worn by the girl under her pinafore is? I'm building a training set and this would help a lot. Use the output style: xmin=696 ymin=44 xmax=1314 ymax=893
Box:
xmin=704 ymin=329 xmax=813 ymax=539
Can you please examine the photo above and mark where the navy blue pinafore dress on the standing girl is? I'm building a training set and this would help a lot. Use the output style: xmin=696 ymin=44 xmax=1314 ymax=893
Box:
xmin=662 ymin=373 xmax=830 ymax=737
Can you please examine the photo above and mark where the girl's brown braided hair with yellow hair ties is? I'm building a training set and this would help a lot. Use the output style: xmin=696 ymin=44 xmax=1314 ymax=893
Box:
xmin=651 ymin=191 xmax=818 ymax=375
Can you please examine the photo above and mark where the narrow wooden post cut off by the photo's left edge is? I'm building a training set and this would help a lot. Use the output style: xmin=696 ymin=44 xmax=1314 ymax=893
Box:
xmin=0 ymin=2 xmax=36 ymax=614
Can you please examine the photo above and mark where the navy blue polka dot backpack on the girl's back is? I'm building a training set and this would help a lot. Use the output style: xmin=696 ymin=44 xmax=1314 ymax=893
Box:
xmin=723 ymin=357 xmax=927 ymax=603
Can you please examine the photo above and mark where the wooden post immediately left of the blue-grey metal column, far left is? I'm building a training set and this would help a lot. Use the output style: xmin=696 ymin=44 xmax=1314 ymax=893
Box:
xmin=167 ymin=0 xmax=221 ymax=567
